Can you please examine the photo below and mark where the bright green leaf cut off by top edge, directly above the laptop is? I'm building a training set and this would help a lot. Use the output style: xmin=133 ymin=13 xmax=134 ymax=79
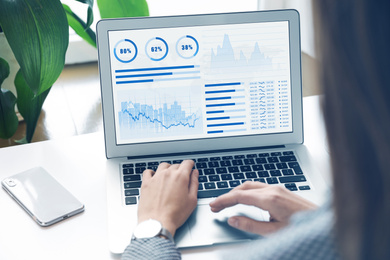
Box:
xmin=97 ymin=0 xmax=149 ymax=18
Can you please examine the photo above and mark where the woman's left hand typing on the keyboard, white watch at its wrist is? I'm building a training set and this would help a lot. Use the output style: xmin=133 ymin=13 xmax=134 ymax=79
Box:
xmin=138 ymin=160 xmax=199 ymax=236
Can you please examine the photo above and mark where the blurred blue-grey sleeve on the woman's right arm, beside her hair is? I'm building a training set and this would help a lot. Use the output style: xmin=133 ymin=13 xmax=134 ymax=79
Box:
xmin=223 ymin=203 xmax=340 ymax=260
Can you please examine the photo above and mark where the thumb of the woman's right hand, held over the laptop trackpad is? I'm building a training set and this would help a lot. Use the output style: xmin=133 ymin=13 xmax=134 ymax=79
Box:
xmin=228 ymin=216 xmax=286 ymax=236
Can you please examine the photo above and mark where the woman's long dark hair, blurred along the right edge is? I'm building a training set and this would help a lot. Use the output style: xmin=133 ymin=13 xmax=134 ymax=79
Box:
xmin=314 ymin=0 xmax=390 ymax=259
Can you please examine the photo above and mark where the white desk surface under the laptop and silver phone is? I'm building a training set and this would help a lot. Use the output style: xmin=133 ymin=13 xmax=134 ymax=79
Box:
xmin=0 ymin=96 xmax=329 ymax=260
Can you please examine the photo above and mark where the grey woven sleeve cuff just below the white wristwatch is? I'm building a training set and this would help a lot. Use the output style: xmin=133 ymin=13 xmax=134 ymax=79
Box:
xmin=122 ymin=237 xmax=181 ymax=260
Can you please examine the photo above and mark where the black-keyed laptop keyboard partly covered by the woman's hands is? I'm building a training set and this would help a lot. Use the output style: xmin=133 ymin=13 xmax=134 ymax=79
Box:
xmin=121 ymin=151 xmax=310 ymax=205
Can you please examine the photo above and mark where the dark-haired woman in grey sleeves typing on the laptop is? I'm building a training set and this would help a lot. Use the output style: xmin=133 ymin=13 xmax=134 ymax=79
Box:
xmin=123 ymin=0 xmax=390 ymax=259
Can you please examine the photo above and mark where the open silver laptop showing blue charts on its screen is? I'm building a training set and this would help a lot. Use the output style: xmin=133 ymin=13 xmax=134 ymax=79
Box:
xmin=97 ymin=10 xmax=326 ymax=253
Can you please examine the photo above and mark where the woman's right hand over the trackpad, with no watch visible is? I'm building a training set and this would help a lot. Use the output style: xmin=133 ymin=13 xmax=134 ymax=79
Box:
xmin=210 ymin=181 xmax=316 ymax=235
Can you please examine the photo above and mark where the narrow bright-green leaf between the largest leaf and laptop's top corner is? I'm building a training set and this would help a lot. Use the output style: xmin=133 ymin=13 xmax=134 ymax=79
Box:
xmin=62 ymin=4 xmax=96 ymax=47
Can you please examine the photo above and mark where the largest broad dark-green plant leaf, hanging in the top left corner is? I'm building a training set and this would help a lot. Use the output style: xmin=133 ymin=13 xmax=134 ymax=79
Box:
xmin=0 ymin=0 xmax=69 ymax=95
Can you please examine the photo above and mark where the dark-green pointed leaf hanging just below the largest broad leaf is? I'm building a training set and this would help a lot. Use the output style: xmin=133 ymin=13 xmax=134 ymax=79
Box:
xmin=15 ymin=69 xmax=51 ymax=142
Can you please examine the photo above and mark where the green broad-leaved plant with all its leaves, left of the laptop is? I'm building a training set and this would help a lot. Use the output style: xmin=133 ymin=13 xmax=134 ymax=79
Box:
xmin=0 ymin=0 xmax=149 ymax=143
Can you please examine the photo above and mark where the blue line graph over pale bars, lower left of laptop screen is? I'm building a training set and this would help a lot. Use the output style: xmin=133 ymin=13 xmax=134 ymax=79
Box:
xmin=117 ymin=88 xmax=203 ymax=139
